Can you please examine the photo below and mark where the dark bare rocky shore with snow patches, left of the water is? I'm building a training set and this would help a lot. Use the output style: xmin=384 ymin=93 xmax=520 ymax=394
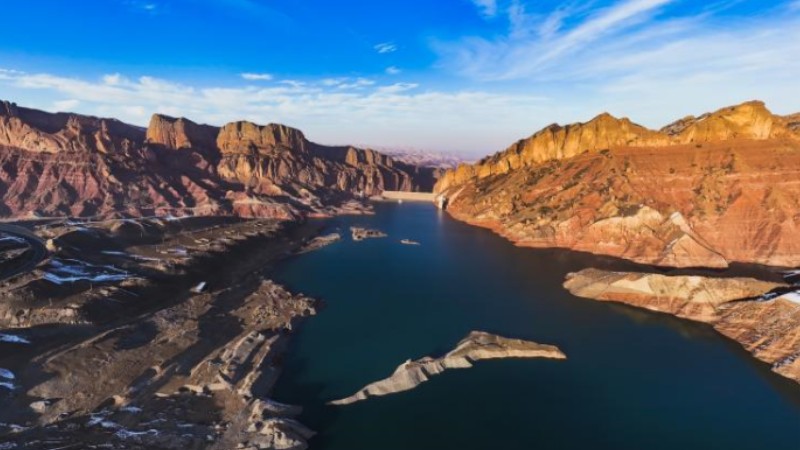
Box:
xmin=0 ymin=214 xmax=332 ymax=449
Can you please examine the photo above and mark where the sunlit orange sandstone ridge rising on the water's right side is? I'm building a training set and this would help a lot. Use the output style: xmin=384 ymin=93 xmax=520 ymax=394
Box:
xmin=435 ymin=101 xmax=800 ymax=268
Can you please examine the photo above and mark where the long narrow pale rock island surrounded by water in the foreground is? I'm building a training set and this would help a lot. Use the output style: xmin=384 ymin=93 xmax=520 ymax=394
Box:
xmin=328 ymin=331 xmax=567 ymax=405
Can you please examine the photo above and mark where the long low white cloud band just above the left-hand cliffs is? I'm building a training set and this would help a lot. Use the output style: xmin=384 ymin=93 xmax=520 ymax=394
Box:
xmin=0 ymin=69 xmax=545 ymax=155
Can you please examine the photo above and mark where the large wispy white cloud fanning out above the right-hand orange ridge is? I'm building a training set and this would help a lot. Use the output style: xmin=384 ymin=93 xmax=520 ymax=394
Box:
xmin=434 ymin=0 xmax=800 ymax=136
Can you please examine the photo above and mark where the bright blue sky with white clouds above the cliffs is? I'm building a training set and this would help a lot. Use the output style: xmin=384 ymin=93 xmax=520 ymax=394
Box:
xmin=0 ymin=0 xmax=800 ymax=155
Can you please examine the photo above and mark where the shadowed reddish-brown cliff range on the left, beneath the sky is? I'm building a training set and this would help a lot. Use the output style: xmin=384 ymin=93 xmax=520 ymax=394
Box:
xmin=0 ymin=102 xmax=435 ymax=219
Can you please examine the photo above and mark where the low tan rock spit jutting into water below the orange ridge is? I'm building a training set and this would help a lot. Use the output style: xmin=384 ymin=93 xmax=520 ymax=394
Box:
xmin=564 ymin=269 xmax=800 ymax=382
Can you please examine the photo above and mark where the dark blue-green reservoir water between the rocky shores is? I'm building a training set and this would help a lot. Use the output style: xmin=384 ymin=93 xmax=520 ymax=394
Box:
xmin=275 ymin=204 xmax=800 ymax=450
